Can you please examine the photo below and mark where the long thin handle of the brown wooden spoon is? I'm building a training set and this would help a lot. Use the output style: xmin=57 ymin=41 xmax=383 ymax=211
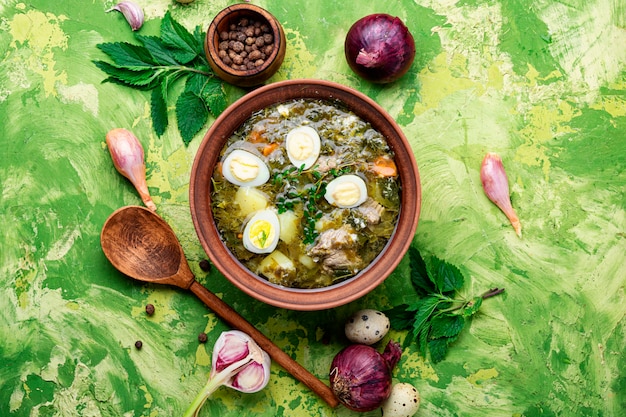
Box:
xmin=189 ymin=280 xmax=339 ymax=408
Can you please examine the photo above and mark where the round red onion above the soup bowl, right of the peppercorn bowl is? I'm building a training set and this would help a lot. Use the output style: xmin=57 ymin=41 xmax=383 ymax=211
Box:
xmin=344 ymin=13 xmax=415 ymax=84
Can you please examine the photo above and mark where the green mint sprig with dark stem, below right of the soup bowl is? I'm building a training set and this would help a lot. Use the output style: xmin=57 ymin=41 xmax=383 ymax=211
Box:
xmin=385 ymin=247 xmax=504 ymax=363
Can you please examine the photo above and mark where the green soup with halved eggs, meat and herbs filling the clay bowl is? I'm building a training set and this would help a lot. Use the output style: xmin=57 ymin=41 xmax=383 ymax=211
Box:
xmin=212 ymin=100 xmax=400 ymax=288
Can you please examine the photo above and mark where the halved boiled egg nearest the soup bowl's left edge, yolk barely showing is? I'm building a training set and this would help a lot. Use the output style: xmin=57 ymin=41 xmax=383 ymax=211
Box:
xmin=222 ymin=149 xmax=270 ymax=187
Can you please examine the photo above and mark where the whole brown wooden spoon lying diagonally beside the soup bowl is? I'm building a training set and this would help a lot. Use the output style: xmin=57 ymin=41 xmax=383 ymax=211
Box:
xmin=100 ymin=206 xmax=339 ymax=408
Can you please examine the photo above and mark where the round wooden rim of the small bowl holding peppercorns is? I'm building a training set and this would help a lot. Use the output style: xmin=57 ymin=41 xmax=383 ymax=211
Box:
xmin=205 ymin=3 xmax=283 ymax=78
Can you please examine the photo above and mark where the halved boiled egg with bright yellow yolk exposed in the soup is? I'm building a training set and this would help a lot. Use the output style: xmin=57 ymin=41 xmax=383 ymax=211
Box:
xmin=243 ymin=209 xmax=280 ymax=254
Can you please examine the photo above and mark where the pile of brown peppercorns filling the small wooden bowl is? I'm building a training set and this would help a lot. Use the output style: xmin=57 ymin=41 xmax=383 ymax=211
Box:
xmin=218 ymin=17 xmax=274 ymax=71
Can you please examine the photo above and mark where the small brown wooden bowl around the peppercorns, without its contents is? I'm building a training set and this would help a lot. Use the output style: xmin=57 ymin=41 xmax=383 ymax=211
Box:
xmin=204 ymin=3 xmax=286 ymax=87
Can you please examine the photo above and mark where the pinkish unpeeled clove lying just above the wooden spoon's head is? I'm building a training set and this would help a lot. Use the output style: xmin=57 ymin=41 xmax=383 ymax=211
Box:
xmin=106 ymin=128 xmax=156 ymax=211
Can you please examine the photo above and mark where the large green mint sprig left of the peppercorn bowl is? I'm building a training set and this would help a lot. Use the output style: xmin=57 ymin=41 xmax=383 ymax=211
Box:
xmin=94 ymin=12 xmax=228 ymax=145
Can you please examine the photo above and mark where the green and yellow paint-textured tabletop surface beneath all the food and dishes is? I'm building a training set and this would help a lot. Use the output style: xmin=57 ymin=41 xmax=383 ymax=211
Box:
xmin=0 ymin=0 xmax=626 ymax=417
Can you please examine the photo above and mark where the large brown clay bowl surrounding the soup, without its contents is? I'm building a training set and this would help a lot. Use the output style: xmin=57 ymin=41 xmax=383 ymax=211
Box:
xmin=189 ymin=80 xmax=421 ymax=311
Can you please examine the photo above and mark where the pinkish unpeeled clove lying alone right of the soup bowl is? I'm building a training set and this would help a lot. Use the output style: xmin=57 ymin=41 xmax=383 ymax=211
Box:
xmin=480 ymin=152 xmax=522 ymax=237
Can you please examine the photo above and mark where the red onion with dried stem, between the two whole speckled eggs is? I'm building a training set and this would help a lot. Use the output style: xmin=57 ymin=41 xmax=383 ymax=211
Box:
xmin=330 ymin=341 xmax=402 ymax=411
